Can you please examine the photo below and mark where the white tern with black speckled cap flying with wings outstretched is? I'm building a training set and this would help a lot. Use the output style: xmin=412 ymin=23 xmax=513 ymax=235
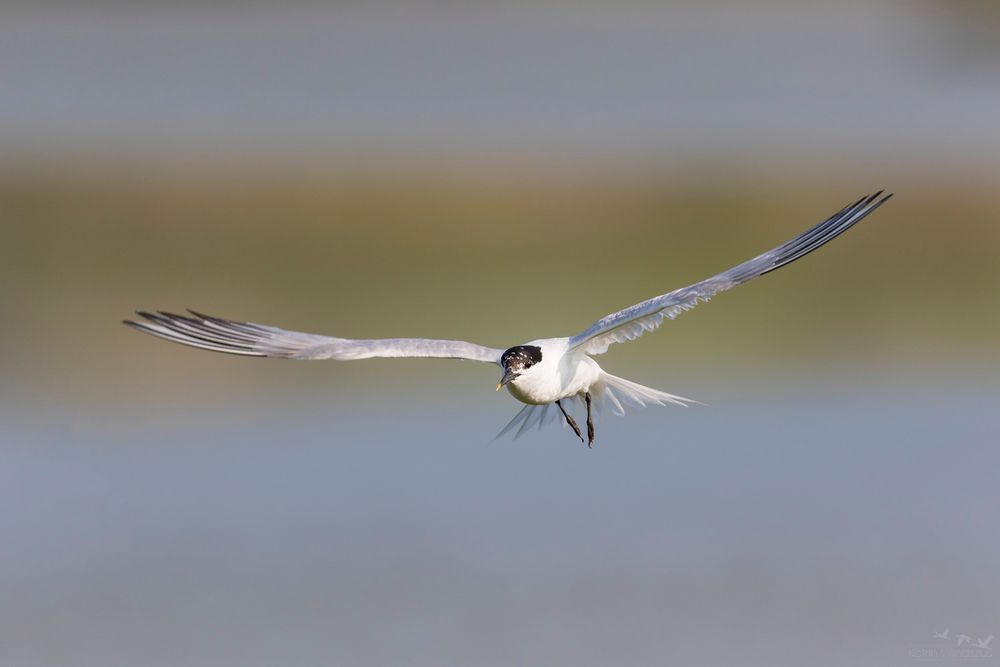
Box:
xmin=124 ymin=191 xmax=892 ymax=446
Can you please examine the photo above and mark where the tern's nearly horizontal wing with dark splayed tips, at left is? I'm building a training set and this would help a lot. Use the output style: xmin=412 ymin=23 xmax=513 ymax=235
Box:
xmin=124 ymin=311 xmax=503 ymax=364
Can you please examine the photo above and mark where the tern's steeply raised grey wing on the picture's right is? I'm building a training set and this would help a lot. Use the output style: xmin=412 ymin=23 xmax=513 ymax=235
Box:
xmin=569 ymin=191 xmax=892 ymax=354
